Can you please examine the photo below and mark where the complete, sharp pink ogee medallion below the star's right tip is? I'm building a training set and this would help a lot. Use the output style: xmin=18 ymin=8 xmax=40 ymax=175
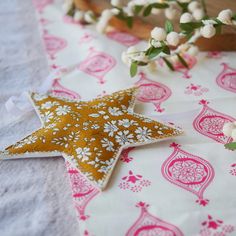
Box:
xmin=161 ymin=143 xmax=214 ymax=206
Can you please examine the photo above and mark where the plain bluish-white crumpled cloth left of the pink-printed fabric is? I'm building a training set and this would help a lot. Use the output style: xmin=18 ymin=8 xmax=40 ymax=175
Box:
xmin=0 ymin=0 xmax=79 ymax=236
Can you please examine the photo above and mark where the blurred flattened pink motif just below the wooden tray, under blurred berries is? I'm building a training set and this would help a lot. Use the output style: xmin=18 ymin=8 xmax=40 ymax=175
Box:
xmin=107 ymin=31 xmax=140 ymax=47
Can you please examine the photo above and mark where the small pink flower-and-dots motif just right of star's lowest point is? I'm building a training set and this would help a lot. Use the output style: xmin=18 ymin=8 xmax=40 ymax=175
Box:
xmin=119 ymin=170 xmax=151 ymax=192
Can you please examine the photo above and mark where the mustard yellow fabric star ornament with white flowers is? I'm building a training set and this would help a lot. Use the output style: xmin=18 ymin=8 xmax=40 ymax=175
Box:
xmin=1 ymin=88 xmax=182 ymax=189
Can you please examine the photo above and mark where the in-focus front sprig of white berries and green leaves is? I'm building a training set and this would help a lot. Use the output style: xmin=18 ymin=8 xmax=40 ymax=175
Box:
xmin=122 ymin=10 xmax=236 ymax=77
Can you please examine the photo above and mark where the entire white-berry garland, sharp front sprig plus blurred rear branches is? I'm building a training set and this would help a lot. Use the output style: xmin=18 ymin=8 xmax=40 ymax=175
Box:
xmin=64 ymin=0 xmax=236 ymax=77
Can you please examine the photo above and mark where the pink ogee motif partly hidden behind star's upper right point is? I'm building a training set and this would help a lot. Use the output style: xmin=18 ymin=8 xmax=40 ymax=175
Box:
xmin=135 ymin=72 xmax=172 ymax=112
